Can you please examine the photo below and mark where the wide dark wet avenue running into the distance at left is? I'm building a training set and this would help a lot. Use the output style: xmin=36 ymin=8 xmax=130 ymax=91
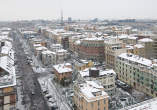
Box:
xmin=13 ymin=33 xmax=49 ymax=110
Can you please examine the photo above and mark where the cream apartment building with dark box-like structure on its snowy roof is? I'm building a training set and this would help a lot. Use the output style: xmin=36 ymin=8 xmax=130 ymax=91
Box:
xmin=78 ymin=67 xmax=116 ymax=96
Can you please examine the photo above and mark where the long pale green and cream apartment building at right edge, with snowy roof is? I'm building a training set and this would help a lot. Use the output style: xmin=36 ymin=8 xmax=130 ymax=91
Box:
xmin=116 ymin=53 xmax=157 ymax=97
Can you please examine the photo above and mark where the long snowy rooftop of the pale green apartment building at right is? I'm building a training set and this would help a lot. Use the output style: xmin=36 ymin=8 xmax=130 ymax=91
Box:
xmin=118 ymin=53 xmax=152 ymax=67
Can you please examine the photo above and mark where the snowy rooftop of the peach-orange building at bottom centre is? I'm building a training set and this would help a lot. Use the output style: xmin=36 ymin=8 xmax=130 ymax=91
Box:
xmin=80 ymin=81 xmax=108 ymax=102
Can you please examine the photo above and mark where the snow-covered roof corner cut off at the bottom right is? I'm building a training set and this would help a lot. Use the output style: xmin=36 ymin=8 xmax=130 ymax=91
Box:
xmin=121 ymin=98 xmax=157 ymax=110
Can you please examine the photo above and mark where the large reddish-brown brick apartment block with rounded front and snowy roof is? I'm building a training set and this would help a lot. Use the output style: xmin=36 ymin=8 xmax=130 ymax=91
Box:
xmin=78 ymin=37 xmax=104 ymax=62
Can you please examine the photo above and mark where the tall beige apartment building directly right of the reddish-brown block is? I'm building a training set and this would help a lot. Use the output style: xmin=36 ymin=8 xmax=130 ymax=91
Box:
xmin=104 ymin=37 xmax=127 ymax=68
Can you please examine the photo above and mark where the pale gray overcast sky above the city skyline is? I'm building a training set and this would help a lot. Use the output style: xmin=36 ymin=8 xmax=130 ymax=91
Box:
xmin=0 ymin=0 xmax=157 ymax=20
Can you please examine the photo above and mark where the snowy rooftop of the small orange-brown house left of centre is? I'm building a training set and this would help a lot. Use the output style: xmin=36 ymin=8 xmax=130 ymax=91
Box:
xmin=53 ymin=63 xmax=72 ymax=73
